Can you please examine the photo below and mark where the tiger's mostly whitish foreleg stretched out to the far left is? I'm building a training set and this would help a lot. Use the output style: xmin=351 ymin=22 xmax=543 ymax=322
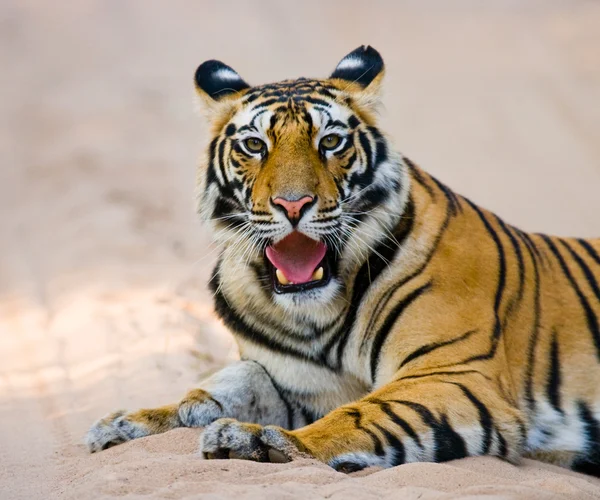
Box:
xmin=85 ymin=361 xmax=293 ymax=453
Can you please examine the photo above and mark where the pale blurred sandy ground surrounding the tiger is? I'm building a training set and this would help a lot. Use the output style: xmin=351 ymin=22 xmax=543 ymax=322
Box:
xmin=0 ymin=0 xmax=600 ymax=499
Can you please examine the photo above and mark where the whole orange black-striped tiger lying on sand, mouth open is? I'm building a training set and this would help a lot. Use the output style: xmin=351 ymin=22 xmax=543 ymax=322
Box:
xmin=86 ymin=46 xmax=600 ymax=475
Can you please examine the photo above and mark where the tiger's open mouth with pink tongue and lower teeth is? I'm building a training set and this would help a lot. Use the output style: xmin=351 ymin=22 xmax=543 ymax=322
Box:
xmin=265 ymin=231 xmax=331 ymax=293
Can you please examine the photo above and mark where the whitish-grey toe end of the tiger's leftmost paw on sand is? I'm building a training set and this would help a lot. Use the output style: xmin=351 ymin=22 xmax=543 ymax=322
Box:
xmin=85 ymin=410 xmax=150 ymax=453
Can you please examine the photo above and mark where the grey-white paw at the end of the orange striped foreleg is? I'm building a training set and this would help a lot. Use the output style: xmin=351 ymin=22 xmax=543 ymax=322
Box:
xmin=200 ymin=418 xmax=311 ymax=463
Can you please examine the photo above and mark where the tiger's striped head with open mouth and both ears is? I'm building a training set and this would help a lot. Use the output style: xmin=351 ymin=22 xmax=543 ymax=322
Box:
xmin=195 ymin=46 xmax=408 ymax=310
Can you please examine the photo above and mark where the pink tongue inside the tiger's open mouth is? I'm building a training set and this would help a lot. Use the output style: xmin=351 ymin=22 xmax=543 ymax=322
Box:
xmin=267 ymin=231 xmax=327 ymax=284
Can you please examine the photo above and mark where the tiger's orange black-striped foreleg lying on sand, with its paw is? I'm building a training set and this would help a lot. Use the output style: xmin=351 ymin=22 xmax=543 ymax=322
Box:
xmin=202 ymin=372 xmax=525 ymax=471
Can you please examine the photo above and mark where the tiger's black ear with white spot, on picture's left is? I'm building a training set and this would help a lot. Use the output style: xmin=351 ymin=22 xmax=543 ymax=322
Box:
xmin=194 ymin=60 xmax=250 ymax=109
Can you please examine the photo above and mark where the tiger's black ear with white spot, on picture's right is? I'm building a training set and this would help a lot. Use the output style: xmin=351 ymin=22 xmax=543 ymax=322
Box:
xmin=329 ymin=45 xmax=384 ymax=96
